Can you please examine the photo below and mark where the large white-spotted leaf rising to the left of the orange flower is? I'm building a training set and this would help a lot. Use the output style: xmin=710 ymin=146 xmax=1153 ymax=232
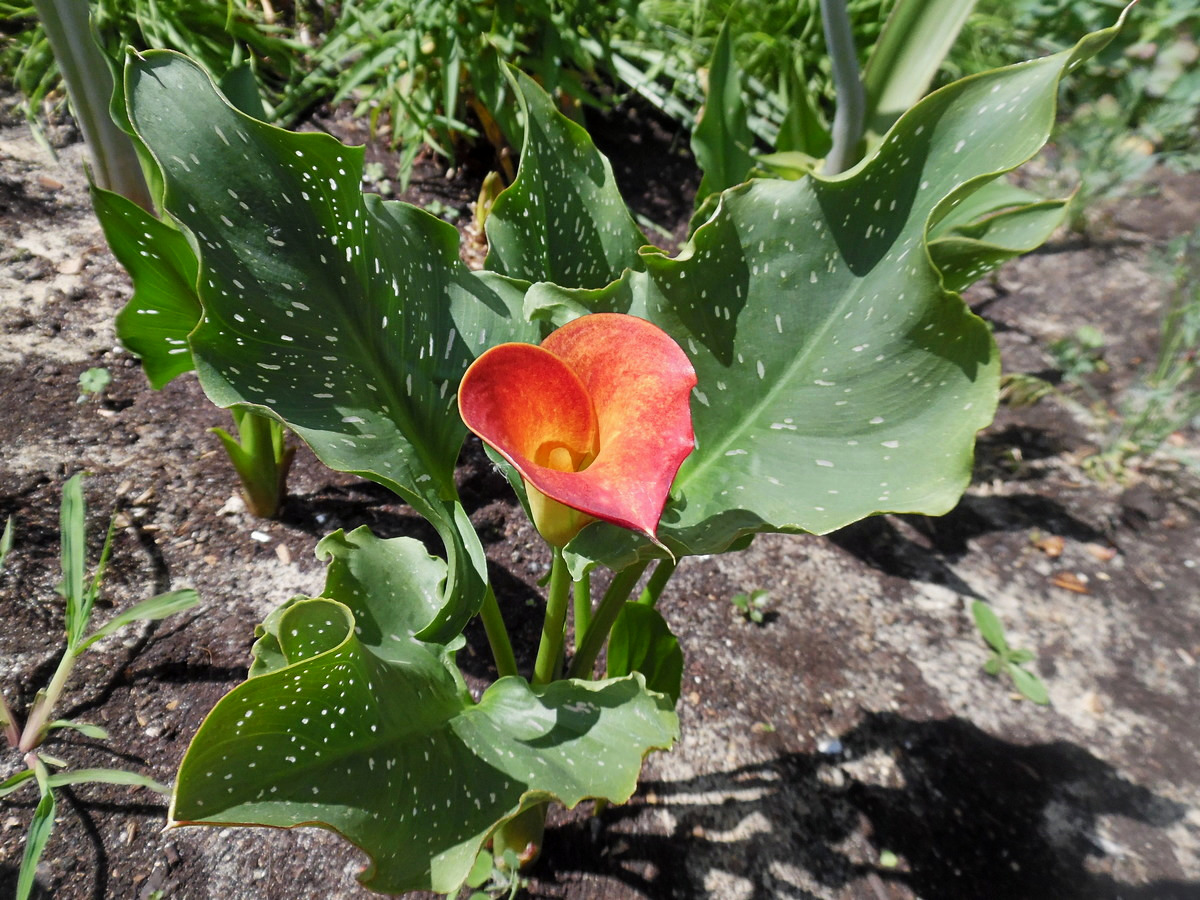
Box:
xmin=126 ymin=52 xmax=535 ymax=641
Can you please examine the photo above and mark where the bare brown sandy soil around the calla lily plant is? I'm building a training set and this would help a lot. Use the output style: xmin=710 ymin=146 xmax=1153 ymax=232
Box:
xmin=0 ymin=93 xmax=1200 ymax=900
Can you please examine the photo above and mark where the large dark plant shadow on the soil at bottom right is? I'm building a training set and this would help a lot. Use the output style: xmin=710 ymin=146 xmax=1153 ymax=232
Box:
xmin=546 ymin=713 xmax=1200 ymax=900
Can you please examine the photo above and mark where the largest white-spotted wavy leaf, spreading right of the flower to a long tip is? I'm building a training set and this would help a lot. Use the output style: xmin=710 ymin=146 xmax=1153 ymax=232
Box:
xmin=540 ymin=10 xmax=1115 ymax=568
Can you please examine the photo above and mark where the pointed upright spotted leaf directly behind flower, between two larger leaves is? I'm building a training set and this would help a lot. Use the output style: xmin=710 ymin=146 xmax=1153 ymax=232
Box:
xmin=486 ymin=70 xmax=646 ymax=288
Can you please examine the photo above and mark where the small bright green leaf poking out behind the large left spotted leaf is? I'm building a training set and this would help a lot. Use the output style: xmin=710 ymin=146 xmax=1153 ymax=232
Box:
xmin=91 ymin=185 xmax=200 ymax=389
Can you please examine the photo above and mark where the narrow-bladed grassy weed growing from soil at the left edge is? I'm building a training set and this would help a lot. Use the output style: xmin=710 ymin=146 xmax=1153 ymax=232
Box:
xmin=0 ymin=475 xmax=198 ymax=900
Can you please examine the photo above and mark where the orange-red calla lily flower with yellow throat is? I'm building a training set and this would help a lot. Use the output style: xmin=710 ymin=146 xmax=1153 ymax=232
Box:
xmin=458 ymin=313 xmax=696 ymax=547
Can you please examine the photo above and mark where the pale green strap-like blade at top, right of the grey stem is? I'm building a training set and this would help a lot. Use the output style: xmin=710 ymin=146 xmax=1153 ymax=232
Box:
xmin=863 ymin=0 xmax=976 ymax=134
